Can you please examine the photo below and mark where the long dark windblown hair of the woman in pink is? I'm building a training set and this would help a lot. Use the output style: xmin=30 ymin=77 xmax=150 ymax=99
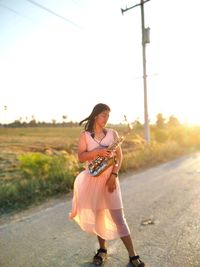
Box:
xmin=79 ymin=103 xmax=110 ymax=133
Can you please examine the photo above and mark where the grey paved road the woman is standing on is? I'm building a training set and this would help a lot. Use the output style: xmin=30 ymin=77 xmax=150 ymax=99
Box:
xmin=0 ymin=153 xmax=200 ymax=267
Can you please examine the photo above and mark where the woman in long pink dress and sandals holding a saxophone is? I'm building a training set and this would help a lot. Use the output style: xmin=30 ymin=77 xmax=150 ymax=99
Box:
xmin=69 ymin=103 xmax=145 ymax=267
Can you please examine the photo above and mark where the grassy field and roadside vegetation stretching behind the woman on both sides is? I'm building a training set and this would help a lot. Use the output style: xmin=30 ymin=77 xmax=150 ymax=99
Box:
xmin=0 ymin=120 xmax=200 ymax=217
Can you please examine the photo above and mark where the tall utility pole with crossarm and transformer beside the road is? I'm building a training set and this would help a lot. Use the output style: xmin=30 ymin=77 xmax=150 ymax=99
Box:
xmin=121 ymin=0 xmax=150 ymax=143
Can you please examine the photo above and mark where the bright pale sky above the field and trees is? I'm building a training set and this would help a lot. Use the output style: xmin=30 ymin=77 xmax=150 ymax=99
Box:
xmin=0 ymin=0 xmax=200 ymax=125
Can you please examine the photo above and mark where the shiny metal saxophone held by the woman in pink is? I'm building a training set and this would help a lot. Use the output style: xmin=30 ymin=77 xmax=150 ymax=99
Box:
xmin=88 ymin=136 xmax=125 ymax=177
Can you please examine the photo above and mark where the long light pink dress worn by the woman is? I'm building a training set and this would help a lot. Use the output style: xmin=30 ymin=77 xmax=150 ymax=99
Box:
xmin=69 ymin=129 xmax=130 ymax=240
